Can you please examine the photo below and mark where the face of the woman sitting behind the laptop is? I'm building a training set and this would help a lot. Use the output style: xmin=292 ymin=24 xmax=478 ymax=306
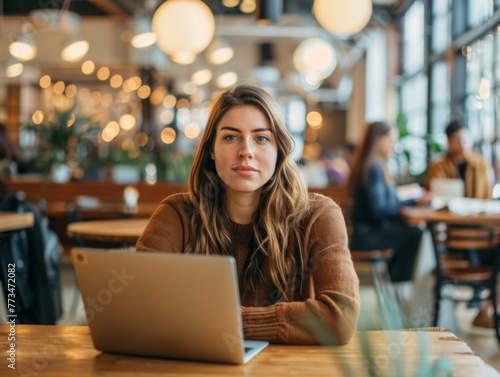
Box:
xmin=212 ymin=106 xmax=278 ymax=193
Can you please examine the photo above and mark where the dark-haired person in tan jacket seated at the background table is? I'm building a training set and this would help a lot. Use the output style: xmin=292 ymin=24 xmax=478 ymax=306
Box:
xmin=425 ymin=120 xmax=492 ymax=199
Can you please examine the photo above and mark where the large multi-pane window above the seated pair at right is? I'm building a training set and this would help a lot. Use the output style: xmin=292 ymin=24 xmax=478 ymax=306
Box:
xmin=401 ymin=0 xmax=500 ymax=180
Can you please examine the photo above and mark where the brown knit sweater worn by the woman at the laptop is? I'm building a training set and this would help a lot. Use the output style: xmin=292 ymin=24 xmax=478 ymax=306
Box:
xmin=137 ymin=194 xmax=359 ymax=344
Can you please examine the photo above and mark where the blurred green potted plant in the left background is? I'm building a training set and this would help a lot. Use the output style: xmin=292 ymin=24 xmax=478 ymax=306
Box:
xmin=26 ymin=105 xmax=100 ymax=182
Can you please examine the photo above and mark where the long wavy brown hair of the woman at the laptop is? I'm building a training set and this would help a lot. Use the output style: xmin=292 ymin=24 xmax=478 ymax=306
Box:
xmin=185 ymin=85 xmax=308 ymax=300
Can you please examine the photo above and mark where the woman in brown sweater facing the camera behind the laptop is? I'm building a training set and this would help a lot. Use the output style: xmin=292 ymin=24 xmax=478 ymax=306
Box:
xmin=137 ymin=86 xmax=359 ymax=344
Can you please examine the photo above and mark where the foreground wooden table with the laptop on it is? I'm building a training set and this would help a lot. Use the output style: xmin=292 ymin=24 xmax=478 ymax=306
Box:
xmin=0 ymin=324 xmax=500 ymax=377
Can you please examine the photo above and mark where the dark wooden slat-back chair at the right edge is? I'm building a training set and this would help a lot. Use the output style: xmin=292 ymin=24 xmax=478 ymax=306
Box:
xmin=432 ymin=224 xmax=500 ymax=342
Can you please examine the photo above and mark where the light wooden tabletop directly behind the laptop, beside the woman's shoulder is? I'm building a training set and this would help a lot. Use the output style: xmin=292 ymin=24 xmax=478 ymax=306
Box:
xmin=67 ymin=218 xmax=149 ymax=244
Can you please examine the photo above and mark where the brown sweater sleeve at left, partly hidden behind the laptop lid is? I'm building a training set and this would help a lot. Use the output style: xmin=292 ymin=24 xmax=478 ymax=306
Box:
xmin=136 ymin=197 xmax=187 ymax=253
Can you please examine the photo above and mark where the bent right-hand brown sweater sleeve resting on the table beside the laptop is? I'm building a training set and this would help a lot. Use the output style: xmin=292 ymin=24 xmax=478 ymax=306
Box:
xmin=242 ymin=199 xmax=359 ymax=344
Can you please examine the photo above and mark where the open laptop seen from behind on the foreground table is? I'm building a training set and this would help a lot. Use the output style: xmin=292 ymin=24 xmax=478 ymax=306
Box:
xmin=72 ymin=248 xmax=269 ymax=364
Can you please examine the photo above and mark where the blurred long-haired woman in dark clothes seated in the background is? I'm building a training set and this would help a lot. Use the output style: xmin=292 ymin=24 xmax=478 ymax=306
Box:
xmin=348 ymin=122 xmax=430 ymax=282
